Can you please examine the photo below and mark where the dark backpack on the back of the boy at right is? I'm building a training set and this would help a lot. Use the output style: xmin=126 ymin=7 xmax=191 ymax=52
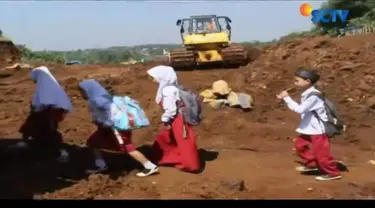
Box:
xmin=307 ymin=91 xmax=346 ymax=138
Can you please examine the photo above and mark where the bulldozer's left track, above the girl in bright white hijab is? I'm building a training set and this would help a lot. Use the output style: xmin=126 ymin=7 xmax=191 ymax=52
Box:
xmin=169 ymin=48 xmax=196 ymax=67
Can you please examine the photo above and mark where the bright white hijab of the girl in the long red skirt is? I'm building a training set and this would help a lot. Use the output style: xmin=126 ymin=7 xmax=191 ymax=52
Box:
xmin=147 ymin=65 xmax=178 ymax=103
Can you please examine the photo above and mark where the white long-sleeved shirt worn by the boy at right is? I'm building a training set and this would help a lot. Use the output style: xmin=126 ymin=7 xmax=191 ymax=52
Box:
xmin=283 ymin=87 xmax=328 ymax=135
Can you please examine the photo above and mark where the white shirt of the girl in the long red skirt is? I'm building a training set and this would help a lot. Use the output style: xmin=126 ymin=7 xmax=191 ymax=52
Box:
xmin=161 ymin=86 xmax=180 ymax=123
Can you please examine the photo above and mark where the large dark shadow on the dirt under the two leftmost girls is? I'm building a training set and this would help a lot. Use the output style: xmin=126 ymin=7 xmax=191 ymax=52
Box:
xmin=0 ymin=139 xmax=144 ymax=199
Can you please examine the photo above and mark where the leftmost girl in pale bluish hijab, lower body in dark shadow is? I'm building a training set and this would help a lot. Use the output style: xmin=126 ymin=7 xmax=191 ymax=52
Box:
xmin=16 ymin=66 xmax=73 ymax=162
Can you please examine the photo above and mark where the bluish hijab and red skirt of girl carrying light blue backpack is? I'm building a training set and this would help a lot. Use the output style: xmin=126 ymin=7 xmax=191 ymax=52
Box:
xmin=80 ymin=80 xmax=136 ymax=153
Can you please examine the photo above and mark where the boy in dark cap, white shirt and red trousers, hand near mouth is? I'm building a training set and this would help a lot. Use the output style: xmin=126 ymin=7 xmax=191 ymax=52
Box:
xmin=277 ymin=69 xmax=341 ymax=181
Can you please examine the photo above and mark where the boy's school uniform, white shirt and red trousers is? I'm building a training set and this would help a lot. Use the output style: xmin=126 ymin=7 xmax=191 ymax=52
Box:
xmin=283 ymin=86 xmax=340 ymax=177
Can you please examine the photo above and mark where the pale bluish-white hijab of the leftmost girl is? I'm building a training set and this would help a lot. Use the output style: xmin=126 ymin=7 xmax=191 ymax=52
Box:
xmin=30 ymin=66 xmax=73 ymax=111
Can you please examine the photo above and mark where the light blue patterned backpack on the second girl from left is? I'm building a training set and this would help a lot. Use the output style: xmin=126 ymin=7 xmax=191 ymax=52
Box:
xmin=110 ymin=96 xmax=150 ymax=131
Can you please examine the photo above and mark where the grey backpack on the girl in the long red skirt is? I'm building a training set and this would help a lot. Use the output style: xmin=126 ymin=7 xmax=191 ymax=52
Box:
xmin=170 ymin=85 xmax=202 ymax=126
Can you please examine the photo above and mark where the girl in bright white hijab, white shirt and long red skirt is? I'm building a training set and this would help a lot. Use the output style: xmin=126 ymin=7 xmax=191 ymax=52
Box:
xmin=147 ymin=65 xmax=200 ymax=172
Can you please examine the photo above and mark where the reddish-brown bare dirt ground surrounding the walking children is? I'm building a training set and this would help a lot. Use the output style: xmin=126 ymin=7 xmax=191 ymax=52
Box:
xmin=0 ymin=35 xmax=375 ymax=199
